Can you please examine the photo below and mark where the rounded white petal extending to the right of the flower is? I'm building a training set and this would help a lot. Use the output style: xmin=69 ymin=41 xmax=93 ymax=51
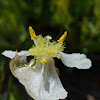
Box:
xmin=59 ymin=51 xmax=91 ymax=69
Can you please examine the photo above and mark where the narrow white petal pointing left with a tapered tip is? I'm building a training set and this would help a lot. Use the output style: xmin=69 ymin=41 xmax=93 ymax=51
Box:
xmin=1 ymin=50 xmax=30 ymax=59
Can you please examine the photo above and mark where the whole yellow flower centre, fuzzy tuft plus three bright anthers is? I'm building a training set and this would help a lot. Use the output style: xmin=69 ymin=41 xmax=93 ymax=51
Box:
xmin=29 ymin=26 xmax=67 ymax=63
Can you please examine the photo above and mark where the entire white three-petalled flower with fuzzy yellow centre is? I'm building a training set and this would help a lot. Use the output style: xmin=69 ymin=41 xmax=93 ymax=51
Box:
xmin=2 ymin=26 xmax=91 ymax=100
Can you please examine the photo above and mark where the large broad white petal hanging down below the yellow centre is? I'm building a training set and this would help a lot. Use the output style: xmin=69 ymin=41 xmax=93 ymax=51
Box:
xmin=15 ymin=60 xmax=67 ymax=100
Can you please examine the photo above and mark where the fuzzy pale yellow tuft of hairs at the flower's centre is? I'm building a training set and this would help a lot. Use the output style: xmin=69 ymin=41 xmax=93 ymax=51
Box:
xmin=29 ymin=35 xmax=65 ymax=59
